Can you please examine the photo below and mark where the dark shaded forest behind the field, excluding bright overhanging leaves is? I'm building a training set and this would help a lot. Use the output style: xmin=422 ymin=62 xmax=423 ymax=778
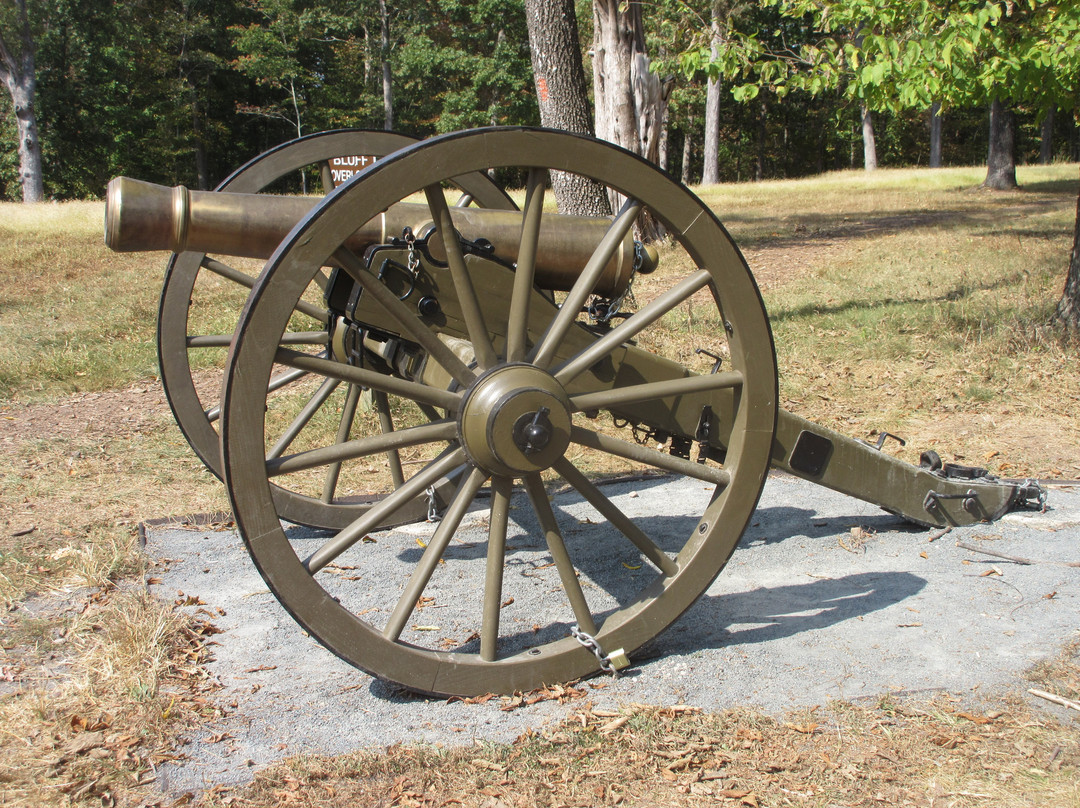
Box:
xmin=0 ymin=0 xmax=1080 ymax=200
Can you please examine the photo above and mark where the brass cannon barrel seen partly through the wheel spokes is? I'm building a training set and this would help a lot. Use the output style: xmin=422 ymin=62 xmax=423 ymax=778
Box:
xmin=105 ymin=177 xmax=657 ymax=297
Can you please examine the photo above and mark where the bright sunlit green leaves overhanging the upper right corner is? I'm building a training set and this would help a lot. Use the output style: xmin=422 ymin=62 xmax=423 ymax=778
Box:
xmin=712 ymin=0 xmax=1080 ymax=110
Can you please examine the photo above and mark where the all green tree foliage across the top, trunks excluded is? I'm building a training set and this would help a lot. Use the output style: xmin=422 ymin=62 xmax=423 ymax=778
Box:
xmin=0 ymin=0 xmax=1080 ymax=199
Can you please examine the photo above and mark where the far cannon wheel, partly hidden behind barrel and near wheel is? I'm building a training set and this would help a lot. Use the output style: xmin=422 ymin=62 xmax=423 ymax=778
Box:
xmin=158 ymin=130 xmax=514 ymax=527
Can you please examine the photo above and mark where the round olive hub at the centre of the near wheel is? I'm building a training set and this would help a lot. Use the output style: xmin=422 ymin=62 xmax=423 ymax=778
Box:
xmin=459 ymin=364 xmax=570 ymax=476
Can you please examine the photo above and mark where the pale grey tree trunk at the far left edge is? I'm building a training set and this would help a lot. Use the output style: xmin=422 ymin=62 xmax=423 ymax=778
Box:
xmin=0 ymin=0 xmax=45 ymax=202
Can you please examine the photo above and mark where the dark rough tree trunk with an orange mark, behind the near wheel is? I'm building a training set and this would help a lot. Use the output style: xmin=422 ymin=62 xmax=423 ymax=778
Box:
xmin=525 ymin=0 xmax=611 ymax=216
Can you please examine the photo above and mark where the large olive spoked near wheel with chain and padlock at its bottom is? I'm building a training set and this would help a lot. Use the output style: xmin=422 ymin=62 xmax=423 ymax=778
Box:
xmin=221 ymin=129 xmax=777 ymax=696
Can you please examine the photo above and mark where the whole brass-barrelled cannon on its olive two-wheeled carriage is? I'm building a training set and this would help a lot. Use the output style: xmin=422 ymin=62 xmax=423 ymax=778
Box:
xmin=106 ymin=127 xmax=1044 ymax=696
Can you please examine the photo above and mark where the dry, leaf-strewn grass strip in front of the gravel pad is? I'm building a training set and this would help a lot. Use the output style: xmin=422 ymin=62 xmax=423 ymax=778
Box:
xmin=206 ymin=696 xmax=1080 ymax=808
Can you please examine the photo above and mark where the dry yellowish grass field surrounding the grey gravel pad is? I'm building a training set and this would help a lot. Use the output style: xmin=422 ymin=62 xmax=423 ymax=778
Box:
xmin=0 ymin=160 xmax=1080 ymax=807
